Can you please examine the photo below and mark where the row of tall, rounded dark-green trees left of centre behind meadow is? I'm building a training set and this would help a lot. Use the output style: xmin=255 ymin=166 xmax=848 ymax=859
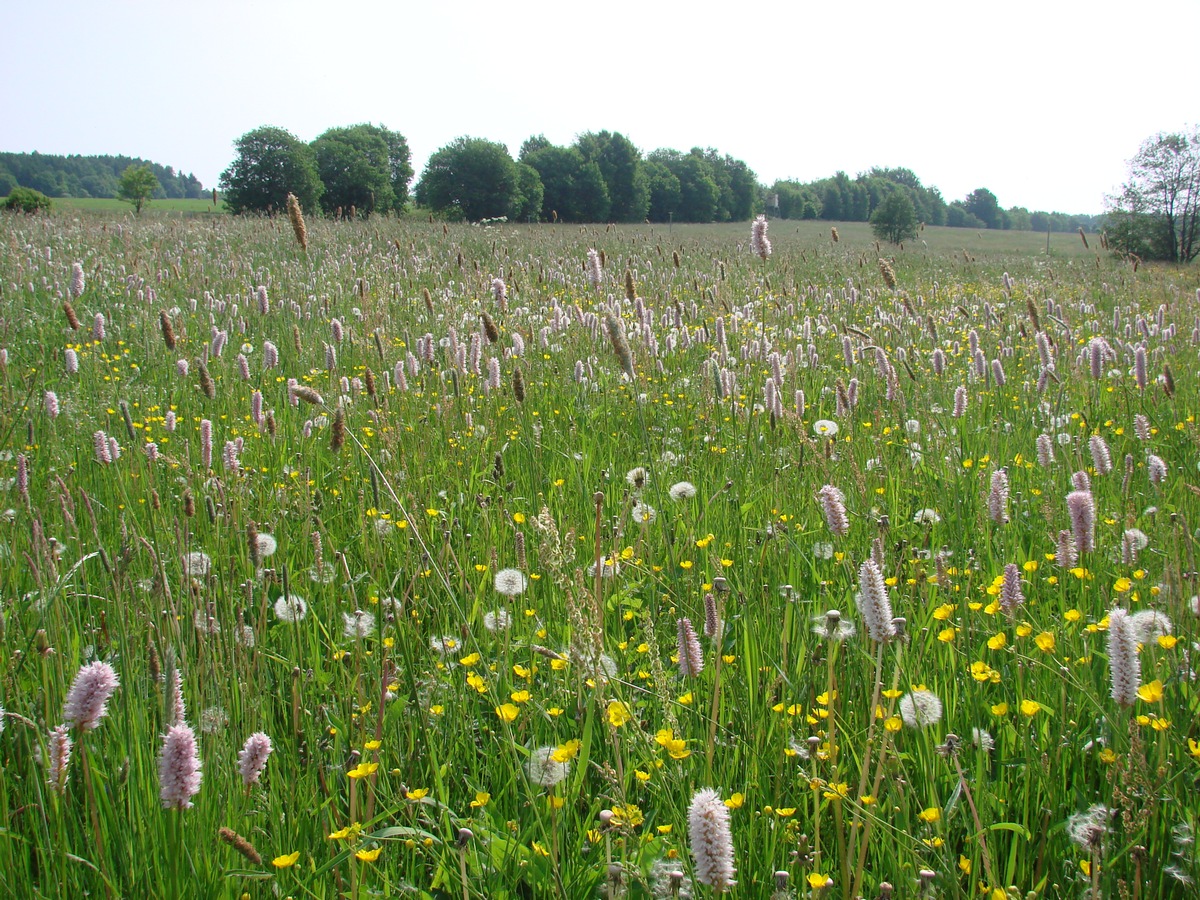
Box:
xmin=221 ymin=125 xmax=762 ymax=222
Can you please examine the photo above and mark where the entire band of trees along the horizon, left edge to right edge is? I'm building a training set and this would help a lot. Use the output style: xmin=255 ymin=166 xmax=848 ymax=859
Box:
xmin=7 ymin=124 xmax=1200 ymax=262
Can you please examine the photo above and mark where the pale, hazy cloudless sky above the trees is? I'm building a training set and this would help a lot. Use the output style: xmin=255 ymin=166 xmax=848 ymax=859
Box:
xmin=0 ymin=0 xmax=1200 ymax=212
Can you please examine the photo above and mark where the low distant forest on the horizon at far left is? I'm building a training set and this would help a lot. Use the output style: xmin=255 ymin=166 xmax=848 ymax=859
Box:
xmin=0 ymin=151 xmax=204 ymax=200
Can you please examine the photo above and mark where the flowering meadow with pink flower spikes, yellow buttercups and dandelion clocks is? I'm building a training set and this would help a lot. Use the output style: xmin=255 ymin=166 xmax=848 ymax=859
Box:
xmin=0 ymin=206 xmax=1200 ymax=900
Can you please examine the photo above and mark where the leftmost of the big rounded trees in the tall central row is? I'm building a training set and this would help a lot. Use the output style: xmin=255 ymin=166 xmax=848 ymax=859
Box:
xmin=221 ymin=126 xmax=324 ymax=212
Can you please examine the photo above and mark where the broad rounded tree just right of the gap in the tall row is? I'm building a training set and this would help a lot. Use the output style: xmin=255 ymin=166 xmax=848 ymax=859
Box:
xmin=414 ymin=137 xmax=523 ymax=221
